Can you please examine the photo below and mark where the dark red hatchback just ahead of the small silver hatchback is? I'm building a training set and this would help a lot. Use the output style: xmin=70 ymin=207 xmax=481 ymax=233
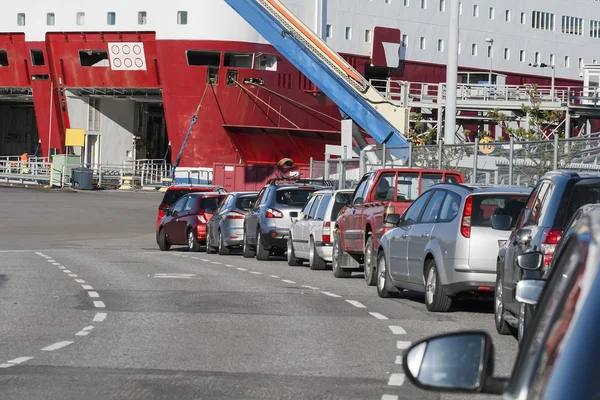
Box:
xmin=156 ymin=192 xmax=225 ymax=251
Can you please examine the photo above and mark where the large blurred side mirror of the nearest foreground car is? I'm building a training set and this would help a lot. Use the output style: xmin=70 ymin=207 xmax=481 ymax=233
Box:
xmin=403 ymin=331 xmax=503 ymax=394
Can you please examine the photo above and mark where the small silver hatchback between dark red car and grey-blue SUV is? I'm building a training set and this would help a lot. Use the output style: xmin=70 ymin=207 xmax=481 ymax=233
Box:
xmin=206 ymin=192 xmax=258 ymax=255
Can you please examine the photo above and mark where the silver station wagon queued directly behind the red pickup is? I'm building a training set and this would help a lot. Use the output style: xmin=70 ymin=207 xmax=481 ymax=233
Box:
xmin=377 ymin=184 xmax=531 ymax=312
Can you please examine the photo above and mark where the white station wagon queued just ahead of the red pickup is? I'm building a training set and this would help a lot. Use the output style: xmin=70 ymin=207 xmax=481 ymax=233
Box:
xmin=287 ymin=189 xmax=354 ymax=270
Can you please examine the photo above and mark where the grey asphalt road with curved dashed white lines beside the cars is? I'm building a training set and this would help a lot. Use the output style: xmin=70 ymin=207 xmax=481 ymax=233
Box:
xmin=0 ymin=188 xmax=517 ymax=400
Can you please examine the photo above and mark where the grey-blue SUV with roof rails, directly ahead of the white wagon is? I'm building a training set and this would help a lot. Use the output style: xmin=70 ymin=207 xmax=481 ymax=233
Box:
xmin=243 ymin=179 xmax=333 ymax=261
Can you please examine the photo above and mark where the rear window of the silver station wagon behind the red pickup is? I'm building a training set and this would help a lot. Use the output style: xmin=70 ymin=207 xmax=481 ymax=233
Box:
xmin=471 ymin=194 xmax=529 ymax=227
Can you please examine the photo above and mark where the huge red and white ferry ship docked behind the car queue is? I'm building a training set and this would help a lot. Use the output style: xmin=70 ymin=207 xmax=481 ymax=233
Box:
xmin=0 ymin=0 xmax=600 ymax=169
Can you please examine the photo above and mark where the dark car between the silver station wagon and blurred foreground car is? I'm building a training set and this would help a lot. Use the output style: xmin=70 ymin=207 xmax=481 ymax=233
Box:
xmin=492 ymin=171 xmax=600 ymax=341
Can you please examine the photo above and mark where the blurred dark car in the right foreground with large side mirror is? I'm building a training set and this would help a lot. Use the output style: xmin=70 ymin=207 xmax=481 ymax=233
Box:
xmin=403 ymin=209 xmax=600 ymax=400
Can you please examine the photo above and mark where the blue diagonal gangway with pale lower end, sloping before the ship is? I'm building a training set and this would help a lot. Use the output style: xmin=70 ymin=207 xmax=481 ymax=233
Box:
xmin=225 ymin=0 xmax=409 ymax=147
